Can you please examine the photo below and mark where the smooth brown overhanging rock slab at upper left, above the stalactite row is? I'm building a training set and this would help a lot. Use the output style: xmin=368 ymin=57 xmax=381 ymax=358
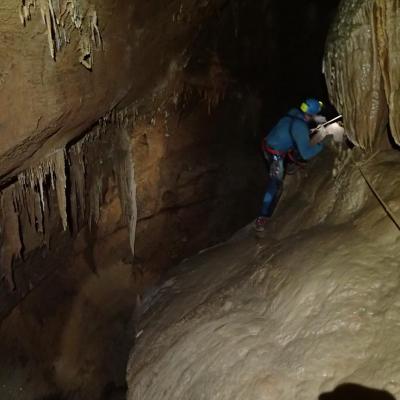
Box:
xmin=0 ymin=0 xmax=225 ymax=181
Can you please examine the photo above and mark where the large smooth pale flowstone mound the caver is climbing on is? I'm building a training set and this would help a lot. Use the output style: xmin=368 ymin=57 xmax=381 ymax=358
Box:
xmin=127 ymin=151 xmax=400 ymax=400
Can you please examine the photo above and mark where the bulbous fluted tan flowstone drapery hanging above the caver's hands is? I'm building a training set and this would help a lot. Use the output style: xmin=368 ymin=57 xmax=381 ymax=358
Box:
xmin=324 ymin=0 xmax=400 ymax=150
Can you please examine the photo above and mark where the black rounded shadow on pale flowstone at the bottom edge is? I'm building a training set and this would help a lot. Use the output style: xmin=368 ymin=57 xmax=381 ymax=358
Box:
xmin=319 ymin=383 xmax=396 ymax=400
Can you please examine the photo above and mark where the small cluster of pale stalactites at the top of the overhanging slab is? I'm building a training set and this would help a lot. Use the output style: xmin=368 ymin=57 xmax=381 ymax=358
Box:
xmin=19 ymin=0 xmax=102 ymax=69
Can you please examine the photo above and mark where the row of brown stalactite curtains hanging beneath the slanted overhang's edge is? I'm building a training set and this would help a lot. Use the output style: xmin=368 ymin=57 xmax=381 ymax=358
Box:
xmin=0 ymin=110 xmax=137 ymax=289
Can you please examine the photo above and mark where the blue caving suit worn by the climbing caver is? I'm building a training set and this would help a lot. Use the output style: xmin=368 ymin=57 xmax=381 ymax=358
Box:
xmin=261 ymin=108 xmax=323 ymax=217
